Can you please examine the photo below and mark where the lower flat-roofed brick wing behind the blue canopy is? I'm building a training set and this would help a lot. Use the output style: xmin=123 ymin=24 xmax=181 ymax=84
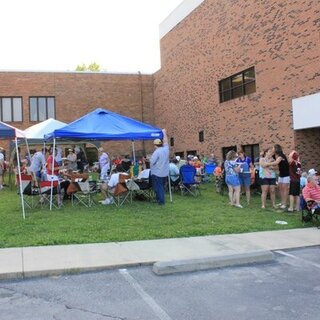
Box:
xmin=0 ymin=72 xmax=154 ymax=155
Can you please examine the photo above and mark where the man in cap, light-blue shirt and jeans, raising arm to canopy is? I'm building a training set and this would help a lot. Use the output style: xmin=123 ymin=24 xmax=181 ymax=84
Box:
xmin=150 ymin=129 xmax=169 ymax=205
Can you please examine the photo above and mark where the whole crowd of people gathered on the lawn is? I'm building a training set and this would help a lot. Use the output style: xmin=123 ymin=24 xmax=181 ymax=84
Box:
xmin=0 ymin=129 xmax=320 ymax=212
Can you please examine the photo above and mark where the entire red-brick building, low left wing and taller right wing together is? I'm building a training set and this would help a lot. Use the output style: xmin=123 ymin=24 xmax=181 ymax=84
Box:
xmin=0 ymin=0 xmax=320 ymax=168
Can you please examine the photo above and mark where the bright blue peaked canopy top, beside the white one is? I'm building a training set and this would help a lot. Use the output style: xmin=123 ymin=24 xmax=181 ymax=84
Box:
xmin=45 ymin=108 xmax=163 ymax=140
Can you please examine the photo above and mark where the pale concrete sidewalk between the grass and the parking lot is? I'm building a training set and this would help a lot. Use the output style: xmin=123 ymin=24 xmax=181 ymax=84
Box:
xmin=0 ymin=228 xmax=320 ymax=279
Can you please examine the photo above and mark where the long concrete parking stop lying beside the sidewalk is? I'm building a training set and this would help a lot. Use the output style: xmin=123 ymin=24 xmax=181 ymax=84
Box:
xmin=152 ymin=250 xmax=274 ymax=275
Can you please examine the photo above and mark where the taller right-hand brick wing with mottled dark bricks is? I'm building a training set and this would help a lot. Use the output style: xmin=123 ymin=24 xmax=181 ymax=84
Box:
xmin=154 ymin=0 xmax=320 ymax=167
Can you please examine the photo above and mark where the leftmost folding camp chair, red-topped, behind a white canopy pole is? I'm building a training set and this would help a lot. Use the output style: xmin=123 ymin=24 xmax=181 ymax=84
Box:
xmin=16 ymin=174 xmax=39 ymax=209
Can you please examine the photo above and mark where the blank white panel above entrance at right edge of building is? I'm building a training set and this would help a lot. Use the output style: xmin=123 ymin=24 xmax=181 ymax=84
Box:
xmin=292 ymin=92 xmax=320 ymax=130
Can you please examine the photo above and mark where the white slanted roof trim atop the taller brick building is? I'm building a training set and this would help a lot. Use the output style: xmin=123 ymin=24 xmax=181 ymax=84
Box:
xmin=160 ymin=0 xmax=204 ymax=39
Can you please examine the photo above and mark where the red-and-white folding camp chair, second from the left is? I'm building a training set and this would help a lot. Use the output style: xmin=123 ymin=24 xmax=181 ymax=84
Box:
xmin=39 ymin=180 xmax=62 ymax=209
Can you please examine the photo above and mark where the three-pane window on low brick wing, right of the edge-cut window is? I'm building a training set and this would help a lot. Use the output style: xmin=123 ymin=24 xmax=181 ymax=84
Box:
xmin=29 ymin=97 xmax=56 ymax=121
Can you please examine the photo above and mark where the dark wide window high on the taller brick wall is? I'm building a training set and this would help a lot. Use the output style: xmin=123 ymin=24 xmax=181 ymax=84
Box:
xmin=219 ymin=67 xmax=256 ymax=102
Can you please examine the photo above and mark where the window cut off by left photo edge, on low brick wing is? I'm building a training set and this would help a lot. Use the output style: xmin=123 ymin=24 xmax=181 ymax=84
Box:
xmin=0 ymin=97 xmax=22 ymax=122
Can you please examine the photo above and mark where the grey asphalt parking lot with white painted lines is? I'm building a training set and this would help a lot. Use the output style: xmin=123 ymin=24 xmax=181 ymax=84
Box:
xmin=0 ymin=247 xmax=320 ymax=320
